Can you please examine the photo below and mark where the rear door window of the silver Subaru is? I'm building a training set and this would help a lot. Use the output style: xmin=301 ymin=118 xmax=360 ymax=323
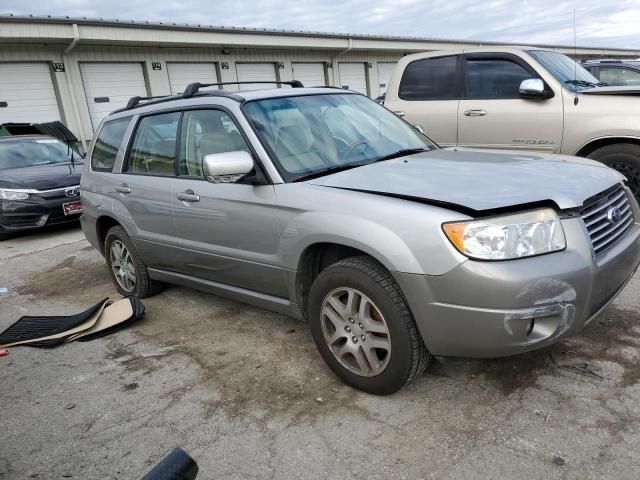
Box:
xmin=126 ymin=112 xmax=180 ymax=176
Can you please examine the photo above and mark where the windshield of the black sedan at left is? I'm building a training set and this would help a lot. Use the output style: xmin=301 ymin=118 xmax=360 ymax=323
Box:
xmin=0 ymin=138 xmax=79 ymax=170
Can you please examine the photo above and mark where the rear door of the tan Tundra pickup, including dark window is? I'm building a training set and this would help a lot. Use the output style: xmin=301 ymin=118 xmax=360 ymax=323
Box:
xmin=385 ymin=55 xmax=461 ymax=147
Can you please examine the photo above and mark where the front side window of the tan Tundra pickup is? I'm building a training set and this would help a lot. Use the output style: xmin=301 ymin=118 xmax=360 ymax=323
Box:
xmin=467 ymin=59 xmax=533 ymax=99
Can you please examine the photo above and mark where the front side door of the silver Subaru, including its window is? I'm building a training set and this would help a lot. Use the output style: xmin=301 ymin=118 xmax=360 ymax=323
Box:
xmin=172 ymin=109 xmax=288 ymax=297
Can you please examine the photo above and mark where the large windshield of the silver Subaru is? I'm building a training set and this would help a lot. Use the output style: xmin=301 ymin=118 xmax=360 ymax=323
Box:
xmin=244 ymin=94 xmax=436 ymax=182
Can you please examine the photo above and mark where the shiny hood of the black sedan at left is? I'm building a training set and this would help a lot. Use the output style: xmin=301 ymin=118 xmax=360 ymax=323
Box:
xmin=0 ymin=162 xmax=83 ymax=190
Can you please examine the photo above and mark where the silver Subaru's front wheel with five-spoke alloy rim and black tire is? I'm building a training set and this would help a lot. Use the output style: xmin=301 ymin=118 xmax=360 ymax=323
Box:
xmin=307 ymin=256 xmax=431 ymax=395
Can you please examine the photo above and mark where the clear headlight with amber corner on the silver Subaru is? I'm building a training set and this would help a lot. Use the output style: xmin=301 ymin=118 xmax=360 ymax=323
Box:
xmin=442 ymin=208 xmax=567 ymax=260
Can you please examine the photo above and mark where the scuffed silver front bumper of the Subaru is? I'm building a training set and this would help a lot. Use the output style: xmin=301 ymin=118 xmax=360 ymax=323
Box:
xmin=394 ymin=216 xmax=640 ymax=357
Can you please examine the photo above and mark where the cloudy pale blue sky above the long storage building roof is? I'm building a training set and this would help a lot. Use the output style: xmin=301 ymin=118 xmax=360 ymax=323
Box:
xmin=0 ymin=0 xmax=640 ymax=48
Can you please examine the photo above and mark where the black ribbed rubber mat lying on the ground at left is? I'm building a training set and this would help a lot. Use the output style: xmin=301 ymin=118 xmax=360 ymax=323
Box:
xmin=0 ymin=298 xmax=108 ymax=347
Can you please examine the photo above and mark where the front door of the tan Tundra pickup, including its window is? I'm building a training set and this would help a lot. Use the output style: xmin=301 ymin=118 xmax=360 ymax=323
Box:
xmin=458 ymin=53 xmax=563 ymax=153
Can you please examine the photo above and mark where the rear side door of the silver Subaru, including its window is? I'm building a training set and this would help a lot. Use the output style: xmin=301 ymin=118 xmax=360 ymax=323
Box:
xmin=113 ymin=112 xmax=180 ymax=268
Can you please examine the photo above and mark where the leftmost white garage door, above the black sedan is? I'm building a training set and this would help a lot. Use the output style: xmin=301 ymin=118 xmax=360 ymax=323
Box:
xmin=0 ymin=62 xmax=60 ymax=123
